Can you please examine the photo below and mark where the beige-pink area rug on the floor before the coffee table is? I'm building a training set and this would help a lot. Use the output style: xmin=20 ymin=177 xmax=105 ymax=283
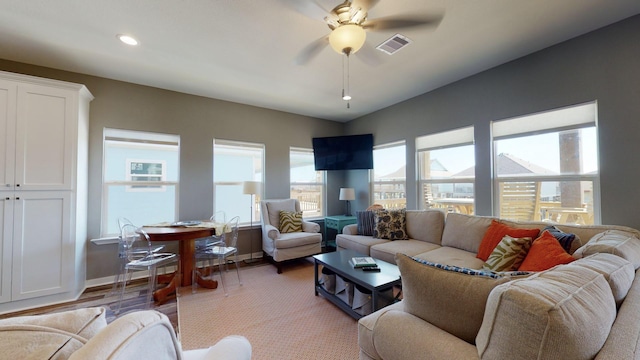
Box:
xmin=178 ymin=261 xmax=359 ymax=360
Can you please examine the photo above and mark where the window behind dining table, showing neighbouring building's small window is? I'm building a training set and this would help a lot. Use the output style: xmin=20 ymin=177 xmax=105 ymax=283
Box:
xmin=102 ymin=129 xmax=180 ymax=236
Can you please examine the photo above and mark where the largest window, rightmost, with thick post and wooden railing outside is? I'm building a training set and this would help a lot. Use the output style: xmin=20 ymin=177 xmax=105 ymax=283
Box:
xmin=492 ymin=103 xmax=599 ymax=225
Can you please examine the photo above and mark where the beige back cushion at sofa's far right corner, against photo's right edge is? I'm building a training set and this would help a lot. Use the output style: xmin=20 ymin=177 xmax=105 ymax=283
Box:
xmin=573 ymin=230 xmax=640 ymax=269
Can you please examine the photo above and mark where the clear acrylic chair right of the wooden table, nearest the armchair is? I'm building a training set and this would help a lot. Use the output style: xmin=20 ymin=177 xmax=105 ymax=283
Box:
xmin=192 ymin=216 xmax=242 ymax=296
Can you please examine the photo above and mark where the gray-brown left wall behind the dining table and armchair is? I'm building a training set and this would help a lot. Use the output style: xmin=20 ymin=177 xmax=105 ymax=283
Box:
xmin=0 ymin=60 xmax=344 ymax=279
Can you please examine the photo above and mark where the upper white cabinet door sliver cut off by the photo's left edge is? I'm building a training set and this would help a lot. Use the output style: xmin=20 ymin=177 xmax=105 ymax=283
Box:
xmin=0 ymin=80 xmax=17 ymax=191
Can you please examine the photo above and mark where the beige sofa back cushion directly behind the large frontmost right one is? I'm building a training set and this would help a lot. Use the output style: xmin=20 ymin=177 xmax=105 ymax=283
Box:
xmin=567 ymin=253 xmax=635 ymax=307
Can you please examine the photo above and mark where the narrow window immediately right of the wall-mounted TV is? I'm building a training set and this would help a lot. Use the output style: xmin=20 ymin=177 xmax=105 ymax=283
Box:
xmin=371 ymin=141 xmax=407 ymax=209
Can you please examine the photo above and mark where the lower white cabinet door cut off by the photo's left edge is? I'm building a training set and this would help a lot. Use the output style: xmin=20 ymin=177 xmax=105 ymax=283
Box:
xmin=0 ymin=191 xmax=13 ymax=303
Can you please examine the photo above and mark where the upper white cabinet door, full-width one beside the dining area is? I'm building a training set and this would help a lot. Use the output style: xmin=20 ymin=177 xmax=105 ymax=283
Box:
xmin=15 ymin=84 xmax=77 ymax=190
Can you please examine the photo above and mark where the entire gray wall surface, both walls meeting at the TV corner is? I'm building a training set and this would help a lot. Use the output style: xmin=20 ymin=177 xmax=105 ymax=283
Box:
xmin=0 ymin=16 xmax=640 ymax=279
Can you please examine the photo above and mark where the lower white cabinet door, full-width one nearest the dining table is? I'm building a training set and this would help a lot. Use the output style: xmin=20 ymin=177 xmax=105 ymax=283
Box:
xmin=12 ymin=191 xmax=75 ymax=300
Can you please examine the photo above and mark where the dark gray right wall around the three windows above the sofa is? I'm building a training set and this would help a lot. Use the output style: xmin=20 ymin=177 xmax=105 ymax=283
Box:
xmin=346 ymin=16 xmax=640 ymax=228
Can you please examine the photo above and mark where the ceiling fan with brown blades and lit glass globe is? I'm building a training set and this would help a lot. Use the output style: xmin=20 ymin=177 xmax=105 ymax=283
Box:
xmin=297 ymin=0 xmax=443 ymax=64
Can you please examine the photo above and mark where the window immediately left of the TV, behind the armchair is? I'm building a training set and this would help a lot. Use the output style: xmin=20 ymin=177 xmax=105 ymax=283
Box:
xmin=289 ymin=148 xmax=326 ymax=218
